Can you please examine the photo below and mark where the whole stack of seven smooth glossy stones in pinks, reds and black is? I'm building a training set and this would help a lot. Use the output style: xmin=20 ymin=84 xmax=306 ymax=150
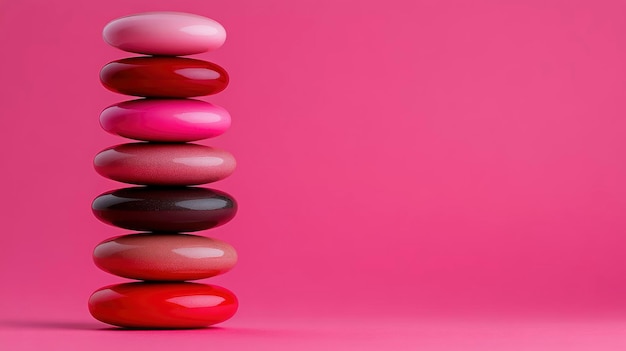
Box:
xmin=89 ymin=12 xmax=237 ymax=328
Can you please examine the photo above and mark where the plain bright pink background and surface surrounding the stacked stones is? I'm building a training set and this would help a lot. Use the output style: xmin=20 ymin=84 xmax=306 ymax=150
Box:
xmin=0 ymin=0 xmax=626 ymax=350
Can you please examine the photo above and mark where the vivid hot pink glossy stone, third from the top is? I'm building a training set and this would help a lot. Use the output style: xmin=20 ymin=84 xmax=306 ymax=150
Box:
xmin=100 ymin=99 xmax=230 ymax=142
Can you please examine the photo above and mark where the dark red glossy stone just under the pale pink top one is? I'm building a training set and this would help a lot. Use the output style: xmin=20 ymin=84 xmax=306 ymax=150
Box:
xmin=100 ymin=56 xmax=228 ymax=98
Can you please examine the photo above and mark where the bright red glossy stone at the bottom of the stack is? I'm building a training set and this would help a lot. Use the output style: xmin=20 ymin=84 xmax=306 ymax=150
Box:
xmin=89 ymin=282 xmax=238 ymax=329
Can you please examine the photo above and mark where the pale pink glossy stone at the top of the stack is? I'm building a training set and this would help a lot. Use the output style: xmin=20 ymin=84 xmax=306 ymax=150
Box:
xmin=102 ymin=12 xmax=226 ymax=56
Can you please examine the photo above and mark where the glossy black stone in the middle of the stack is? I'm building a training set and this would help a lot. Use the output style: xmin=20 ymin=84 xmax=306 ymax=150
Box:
xmin=91 ymin=187 xmax=237 ymax=232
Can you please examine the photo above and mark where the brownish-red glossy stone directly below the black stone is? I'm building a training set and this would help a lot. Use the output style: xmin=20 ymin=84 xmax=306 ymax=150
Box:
xmin=93 ymin=233 xmax=237 ymax=281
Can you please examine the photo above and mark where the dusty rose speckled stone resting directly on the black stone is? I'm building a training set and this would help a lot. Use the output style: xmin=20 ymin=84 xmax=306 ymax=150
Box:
xmin=93 ymin=143 xmax=236 ymax=186
